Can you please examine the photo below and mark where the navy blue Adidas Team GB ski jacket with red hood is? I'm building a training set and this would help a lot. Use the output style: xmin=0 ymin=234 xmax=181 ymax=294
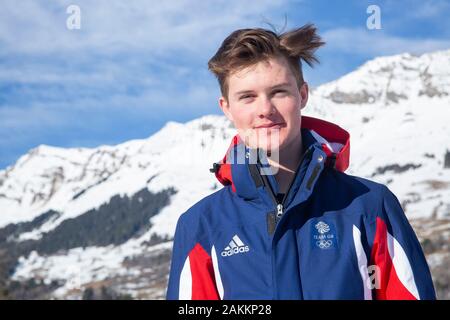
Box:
xmin=167 ymin=116 xmax=435 ymax=299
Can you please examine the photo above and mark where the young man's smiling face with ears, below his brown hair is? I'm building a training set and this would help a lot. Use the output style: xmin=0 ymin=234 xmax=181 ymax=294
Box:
xmin=219 ymin=58 xmax=308 ymax=151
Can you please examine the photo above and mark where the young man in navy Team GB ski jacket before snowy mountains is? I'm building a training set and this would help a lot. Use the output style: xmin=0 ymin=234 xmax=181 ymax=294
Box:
xmin=167 ymin=25 xmax=435 ymax=299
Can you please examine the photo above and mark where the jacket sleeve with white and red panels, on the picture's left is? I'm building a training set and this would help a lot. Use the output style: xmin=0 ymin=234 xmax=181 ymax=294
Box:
xmin=166 ymin=215 xmax=219 ymax=300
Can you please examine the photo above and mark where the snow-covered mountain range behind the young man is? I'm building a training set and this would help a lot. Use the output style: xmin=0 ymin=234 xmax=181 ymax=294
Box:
xmin=0 ymin=50 xmax=450 ymax=298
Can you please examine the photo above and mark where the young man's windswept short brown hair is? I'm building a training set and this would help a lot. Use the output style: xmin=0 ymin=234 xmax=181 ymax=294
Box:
xmin=208 ymin=24 xmax=325 ymax=100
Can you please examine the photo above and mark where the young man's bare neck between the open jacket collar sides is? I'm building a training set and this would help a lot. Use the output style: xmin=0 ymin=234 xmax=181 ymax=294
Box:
xmin=268 ymin=135 xmax=303 ymax=193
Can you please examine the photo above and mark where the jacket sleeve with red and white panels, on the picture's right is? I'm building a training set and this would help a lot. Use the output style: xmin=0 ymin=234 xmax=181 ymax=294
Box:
xmin=371 ymin=187 xmax=436 ymax=300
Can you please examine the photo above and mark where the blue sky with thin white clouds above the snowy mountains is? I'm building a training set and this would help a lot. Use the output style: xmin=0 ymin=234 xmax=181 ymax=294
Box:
xmin=0 ymin=0 xmax=450 ymax=169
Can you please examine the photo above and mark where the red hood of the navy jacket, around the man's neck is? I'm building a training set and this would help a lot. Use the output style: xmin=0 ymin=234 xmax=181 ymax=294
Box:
xmin=211 ymin=116 xmax=350 ymax=191
